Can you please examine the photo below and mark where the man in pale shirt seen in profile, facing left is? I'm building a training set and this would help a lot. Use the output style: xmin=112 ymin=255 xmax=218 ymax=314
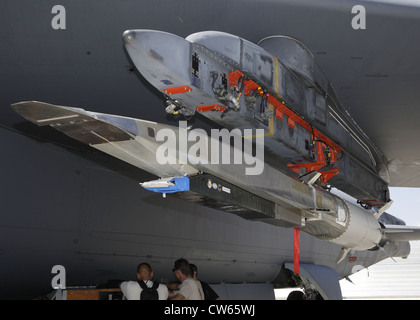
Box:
xmin=169 ymin=259 xmax=204 ymax=300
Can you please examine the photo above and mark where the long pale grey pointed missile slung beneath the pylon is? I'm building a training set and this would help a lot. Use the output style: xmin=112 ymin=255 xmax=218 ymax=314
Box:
xmin=12 ymin=101 xmax=390 ymax=254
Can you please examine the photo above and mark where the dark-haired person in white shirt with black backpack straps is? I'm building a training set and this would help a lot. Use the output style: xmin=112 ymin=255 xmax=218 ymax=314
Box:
xmin=120 ymin=262 xmax=168 ymax=300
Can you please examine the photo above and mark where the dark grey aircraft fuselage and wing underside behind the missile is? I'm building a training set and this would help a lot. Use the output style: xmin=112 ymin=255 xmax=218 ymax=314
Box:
xmin=0 ymin=0 xmax=420 ymax=298
